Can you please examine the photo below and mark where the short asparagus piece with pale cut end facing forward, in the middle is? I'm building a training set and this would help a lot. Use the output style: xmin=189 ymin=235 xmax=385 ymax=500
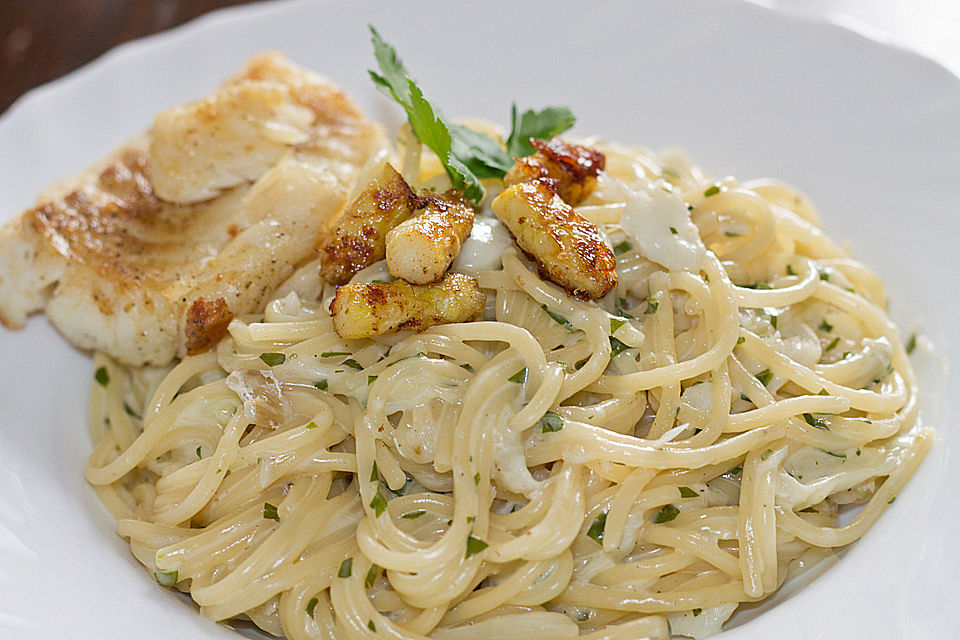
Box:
xmin=386 ymin=189 xmax=473 ymax=284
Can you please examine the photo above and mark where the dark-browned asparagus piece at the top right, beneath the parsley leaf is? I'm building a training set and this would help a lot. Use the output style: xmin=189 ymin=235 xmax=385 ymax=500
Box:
xmin=503 ymin=138 xmax=605 ymax=206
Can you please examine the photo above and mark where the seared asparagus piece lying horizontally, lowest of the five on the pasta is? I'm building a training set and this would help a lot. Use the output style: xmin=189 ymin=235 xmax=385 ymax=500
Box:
xmin=330 ymin=273 xmax=486 ymax=339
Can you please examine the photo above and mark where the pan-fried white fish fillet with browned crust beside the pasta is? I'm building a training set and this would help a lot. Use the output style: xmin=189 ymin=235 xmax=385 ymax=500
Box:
xmin=0 ymin=53 xmax=386 ymax=365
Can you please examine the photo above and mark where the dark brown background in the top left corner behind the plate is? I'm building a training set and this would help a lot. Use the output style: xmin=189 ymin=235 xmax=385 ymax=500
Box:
xmin=0 ymin=0 xmax=262 ymax=113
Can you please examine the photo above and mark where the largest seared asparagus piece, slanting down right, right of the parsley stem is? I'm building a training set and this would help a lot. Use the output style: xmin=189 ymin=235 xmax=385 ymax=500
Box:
xmin=493 ymin=180 xmax=617 ymax=298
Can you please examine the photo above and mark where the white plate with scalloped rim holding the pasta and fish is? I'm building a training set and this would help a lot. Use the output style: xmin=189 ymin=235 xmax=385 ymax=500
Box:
xmin=0 ymin=0 xmax=960 ymax=640
